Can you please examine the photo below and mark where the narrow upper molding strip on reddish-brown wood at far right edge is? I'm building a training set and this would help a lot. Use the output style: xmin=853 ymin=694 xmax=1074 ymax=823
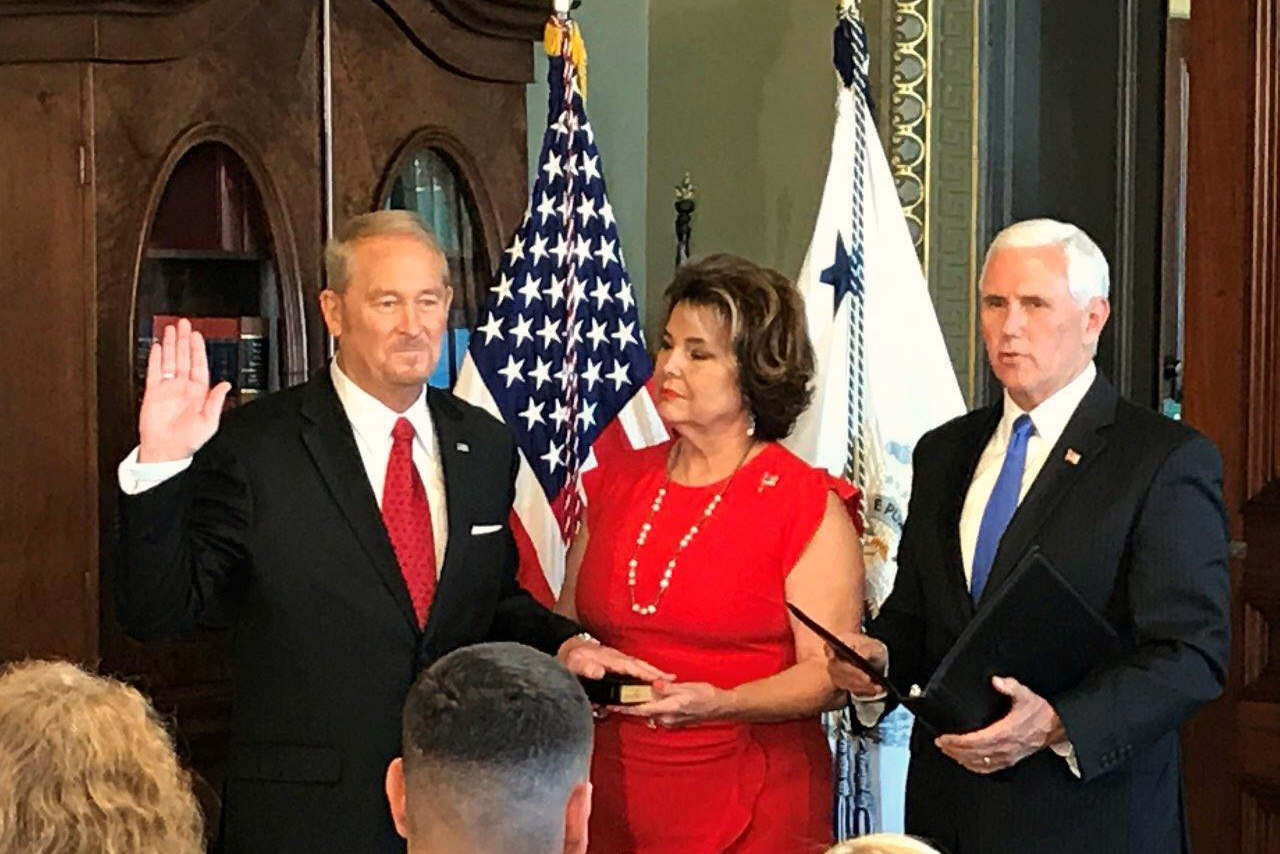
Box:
xmin=1247 ymin=0 xmax=1280 ymax=499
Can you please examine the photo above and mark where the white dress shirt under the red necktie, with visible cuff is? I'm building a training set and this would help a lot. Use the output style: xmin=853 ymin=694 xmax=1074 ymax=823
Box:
xmin=118 ymin=359 xmax=449 ymax=575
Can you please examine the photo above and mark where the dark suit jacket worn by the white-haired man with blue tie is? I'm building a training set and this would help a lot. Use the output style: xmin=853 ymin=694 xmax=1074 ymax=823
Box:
xmin=869 ymin=375 xmax=1229 ymax=854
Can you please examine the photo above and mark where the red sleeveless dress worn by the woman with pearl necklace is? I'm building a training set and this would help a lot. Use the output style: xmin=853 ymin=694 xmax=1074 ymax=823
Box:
xmin=576 ymin=443 xmax=858 ymax=854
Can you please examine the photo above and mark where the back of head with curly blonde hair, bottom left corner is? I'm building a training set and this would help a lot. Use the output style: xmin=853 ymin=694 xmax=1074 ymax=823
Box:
xmin=0 ymin=661 xmax=204 ymax=854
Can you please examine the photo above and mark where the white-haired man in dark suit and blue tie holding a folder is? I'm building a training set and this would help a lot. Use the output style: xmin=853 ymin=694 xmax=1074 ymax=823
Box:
xmin=829 ymin=219 xmax=1229 ymax=854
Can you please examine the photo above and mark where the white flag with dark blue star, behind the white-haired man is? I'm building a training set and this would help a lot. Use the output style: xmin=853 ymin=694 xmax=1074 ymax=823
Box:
xmin=786 ymin=8 xmax=965 ymax=839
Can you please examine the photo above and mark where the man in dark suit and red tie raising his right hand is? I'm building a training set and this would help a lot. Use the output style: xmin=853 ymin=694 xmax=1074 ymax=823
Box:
xmin=115 ymin=211 xmax=664 ymax=854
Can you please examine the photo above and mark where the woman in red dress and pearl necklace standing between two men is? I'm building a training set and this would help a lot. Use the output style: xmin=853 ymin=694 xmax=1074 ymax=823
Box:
xmin=559 ymin=255 xmax=863 ymax=854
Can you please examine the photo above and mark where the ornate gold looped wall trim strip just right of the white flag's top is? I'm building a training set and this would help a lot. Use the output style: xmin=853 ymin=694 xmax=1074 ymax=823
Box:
xmin=888 ymin=0 xmax=933 ymax=275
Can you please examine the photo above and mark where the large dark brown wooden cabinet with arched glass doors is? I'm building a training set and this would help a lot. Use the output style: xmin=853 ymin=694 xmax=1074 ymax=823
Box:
xmin=0 ymin=0 xmax=550 ymax=809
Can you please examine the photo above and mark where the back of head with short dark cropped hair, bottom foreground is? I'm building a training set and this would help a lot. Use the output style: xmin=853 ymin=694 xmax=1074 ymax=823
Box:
xmin=387 ymin=643 xmax=593 ymax=854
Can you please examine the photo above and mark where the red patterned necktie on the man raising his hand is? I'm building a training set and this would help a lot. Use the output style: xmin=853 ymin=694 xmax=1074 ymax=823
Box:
xmin=383 ymin=419 xmax=435 ymax=626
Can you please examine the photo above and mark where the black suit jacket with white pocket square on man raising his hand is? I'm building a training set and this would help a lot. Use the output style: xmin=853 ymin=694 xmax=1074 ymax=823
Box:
xmin=115 ymin=369 xmax=581 ymax=854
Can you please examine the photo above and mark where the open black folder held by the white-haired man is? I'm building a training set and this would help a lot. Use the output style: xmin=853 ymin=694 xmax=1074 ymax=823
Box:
xmin=787 ymin=548 xmax=1119 ymax=732
